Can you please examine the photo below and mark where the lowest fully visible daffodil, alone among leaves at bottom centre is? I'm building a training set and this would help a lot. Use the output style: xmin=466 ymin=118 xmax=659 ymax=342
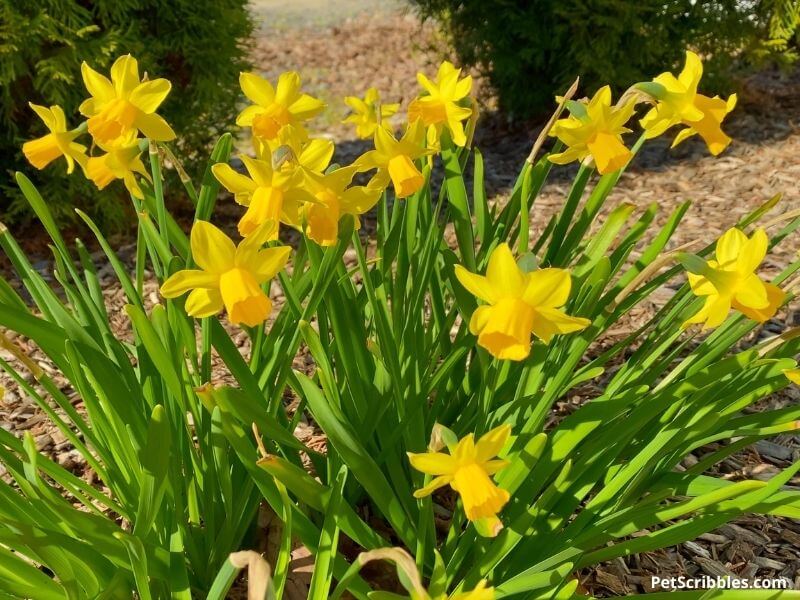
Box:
xmin=408 ymin=425 xmax=511 ymax=521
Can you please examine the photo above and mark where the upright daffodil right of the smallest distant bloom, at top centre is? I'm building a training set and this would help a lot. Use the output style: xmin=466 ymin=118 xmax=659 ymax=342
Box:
xmin=408 ymin=61 xmax=472 ymax=146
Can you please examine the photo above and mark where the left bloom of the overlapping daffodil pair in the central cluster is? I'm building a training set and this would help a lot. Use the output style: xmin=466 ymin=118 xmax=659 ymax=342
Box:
xmin=211 ymin=149 xmax=317 ymax=240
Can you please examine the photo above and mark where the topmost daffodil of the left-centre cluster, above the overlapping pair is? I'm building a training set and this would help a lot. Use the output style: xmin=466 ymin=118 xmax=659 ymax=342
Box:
xmin=236 ymin=71 xmax=325 ymax=140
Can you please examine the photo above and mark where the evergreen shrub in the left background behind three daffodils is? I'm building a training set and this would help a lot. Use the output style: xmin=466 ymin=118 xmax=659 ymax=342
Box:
xmin=0 ymin=0 xmax=253 ymax=225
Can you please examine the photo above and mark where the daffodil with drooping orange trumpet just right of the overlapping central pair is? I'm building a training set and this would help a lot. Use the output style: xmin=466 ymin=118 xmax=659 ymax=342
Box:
xmin=353 ymin=119 xmax=431 ymax=198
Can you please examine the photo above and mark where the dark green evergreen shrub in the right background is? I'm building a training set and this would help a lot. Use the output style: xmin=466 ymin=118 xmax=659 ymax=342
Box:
xmin=411 ymin=0 xmax=800 ymax=117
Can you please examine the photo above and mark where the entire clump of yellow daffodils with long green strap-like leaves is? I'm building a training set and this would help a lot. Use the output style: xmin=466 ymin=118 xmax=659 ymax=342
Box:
xmin=0 ymin=52 xmax=800 ymax=600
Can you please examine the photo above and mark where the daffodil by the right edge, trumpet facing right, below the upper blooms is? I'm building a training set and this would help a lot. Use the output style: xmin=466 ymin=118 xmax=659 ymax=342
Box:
xmin=683 ymin=228 xmax=785 ymax=329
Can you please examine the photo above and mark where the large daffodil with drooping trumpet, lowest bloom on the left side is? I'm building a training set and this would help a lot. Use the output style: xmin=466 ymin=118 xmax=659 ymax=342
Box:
xmin=161 ymin=221 xmax=291 ymax=327
